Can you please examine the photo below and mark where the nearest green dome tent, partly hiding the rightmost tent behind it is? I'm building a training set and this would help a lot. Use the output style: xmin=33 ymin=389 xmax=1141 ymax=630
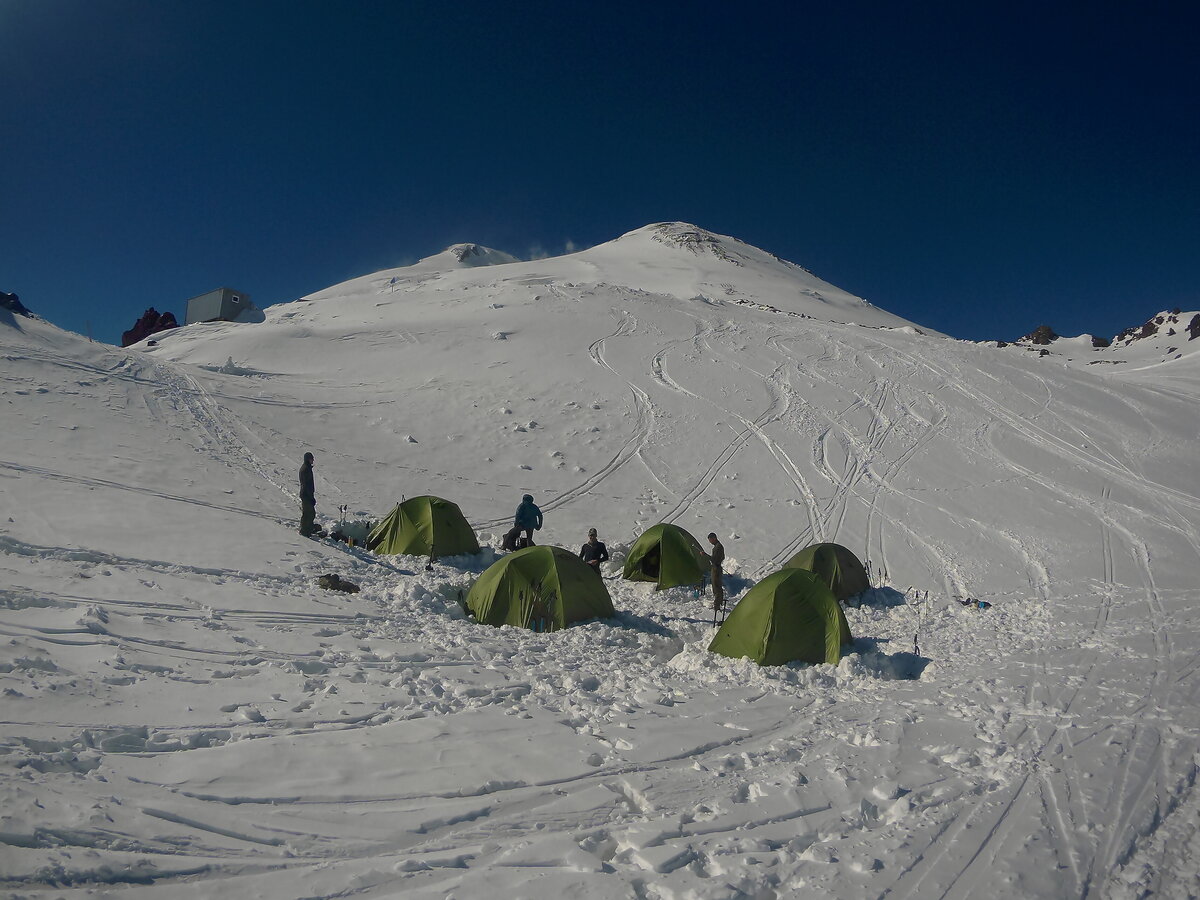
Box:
xmin=708 ymin=569 xmax=853 ymax=666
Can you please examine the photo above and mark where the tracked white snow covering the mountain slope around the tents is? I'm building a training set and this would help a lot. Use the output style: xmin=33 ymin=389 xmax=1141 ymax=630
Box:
xmin=0 ymin=223 xmax=1200 ymax=899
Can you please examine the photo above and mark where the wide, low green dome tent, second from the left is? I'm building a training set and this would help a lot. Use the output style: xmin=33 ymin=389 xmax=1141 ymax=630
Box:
xmin=467 ymin=546 xmax=617 ymax=631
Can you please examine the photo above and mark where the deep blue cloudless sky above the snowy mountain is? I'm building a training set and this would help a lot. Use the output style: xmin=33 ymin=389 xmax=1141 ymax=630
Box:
xmin=0 ymin=0 xmax=1200 ymax=342
